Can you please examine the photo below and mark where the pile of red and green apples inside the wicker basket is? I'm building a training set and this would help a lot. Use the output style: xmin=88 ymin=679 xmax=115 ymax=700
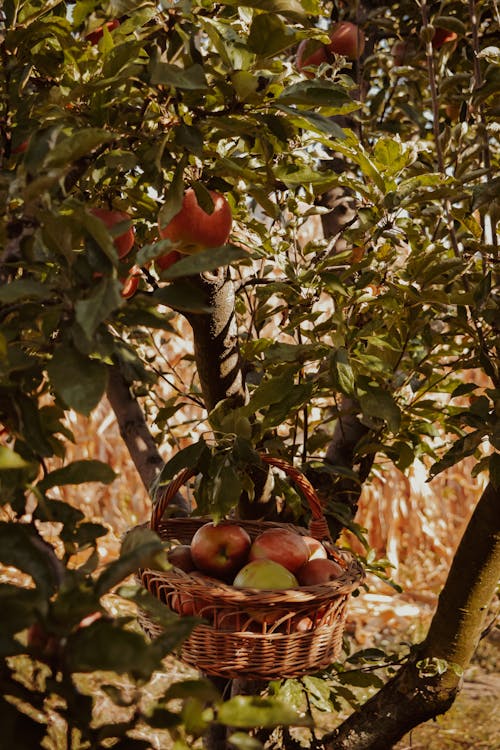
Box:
xmin=168 ymin=522 xmax=345 ymax=629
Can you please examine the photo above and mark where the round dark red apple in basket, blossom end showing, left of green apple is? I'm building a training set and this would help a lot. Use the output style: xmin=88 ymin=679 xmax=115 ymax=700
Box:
xmin=191 ymin=521 xmax=252 ymax=580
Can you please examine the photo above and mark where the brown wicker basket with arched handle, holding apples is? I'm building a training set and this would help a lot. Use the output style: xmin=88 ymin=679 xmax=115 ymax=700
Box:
xmin=138 ymin=455 xmax=364 ymax=680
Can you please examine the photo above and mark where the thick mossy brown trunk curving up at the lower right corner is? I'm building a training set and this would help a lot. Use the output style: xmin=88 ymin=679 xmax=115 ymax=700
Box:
xmin=323 ymin=484 xmax=500 ymax=750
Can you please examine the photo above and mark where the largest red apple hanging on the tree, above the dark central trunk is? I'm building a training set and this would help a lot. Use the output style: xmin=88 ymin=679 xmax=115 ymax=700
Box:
xmin=159 ymin=188 xmax=233 ymax=254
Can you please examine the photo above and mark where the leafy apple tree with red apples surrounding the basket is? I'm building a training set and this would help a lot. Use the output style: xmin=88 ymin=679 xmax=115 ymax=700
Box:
xmin=0 ymin=0 xmax=500 ymax=750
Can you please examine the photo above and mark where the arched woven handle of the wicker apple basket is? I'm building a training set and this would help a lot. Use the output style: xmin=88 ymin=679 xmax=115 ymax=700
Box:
xmin=150 ymin=453 xmax=331 ymax=541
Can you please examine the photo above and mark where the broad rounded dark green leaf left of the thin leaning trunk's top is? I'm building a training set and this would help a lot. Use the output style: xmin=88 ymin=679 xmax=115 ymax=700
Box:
xmin=47 ymin=347 xmax=107 ymax=416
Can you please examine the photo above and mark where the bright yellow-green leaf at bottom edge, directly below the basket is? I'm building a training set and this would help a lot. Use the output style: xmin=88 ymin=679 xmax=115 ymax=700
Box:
xmin=217 ymin=695 xmax=312 ymax=729
